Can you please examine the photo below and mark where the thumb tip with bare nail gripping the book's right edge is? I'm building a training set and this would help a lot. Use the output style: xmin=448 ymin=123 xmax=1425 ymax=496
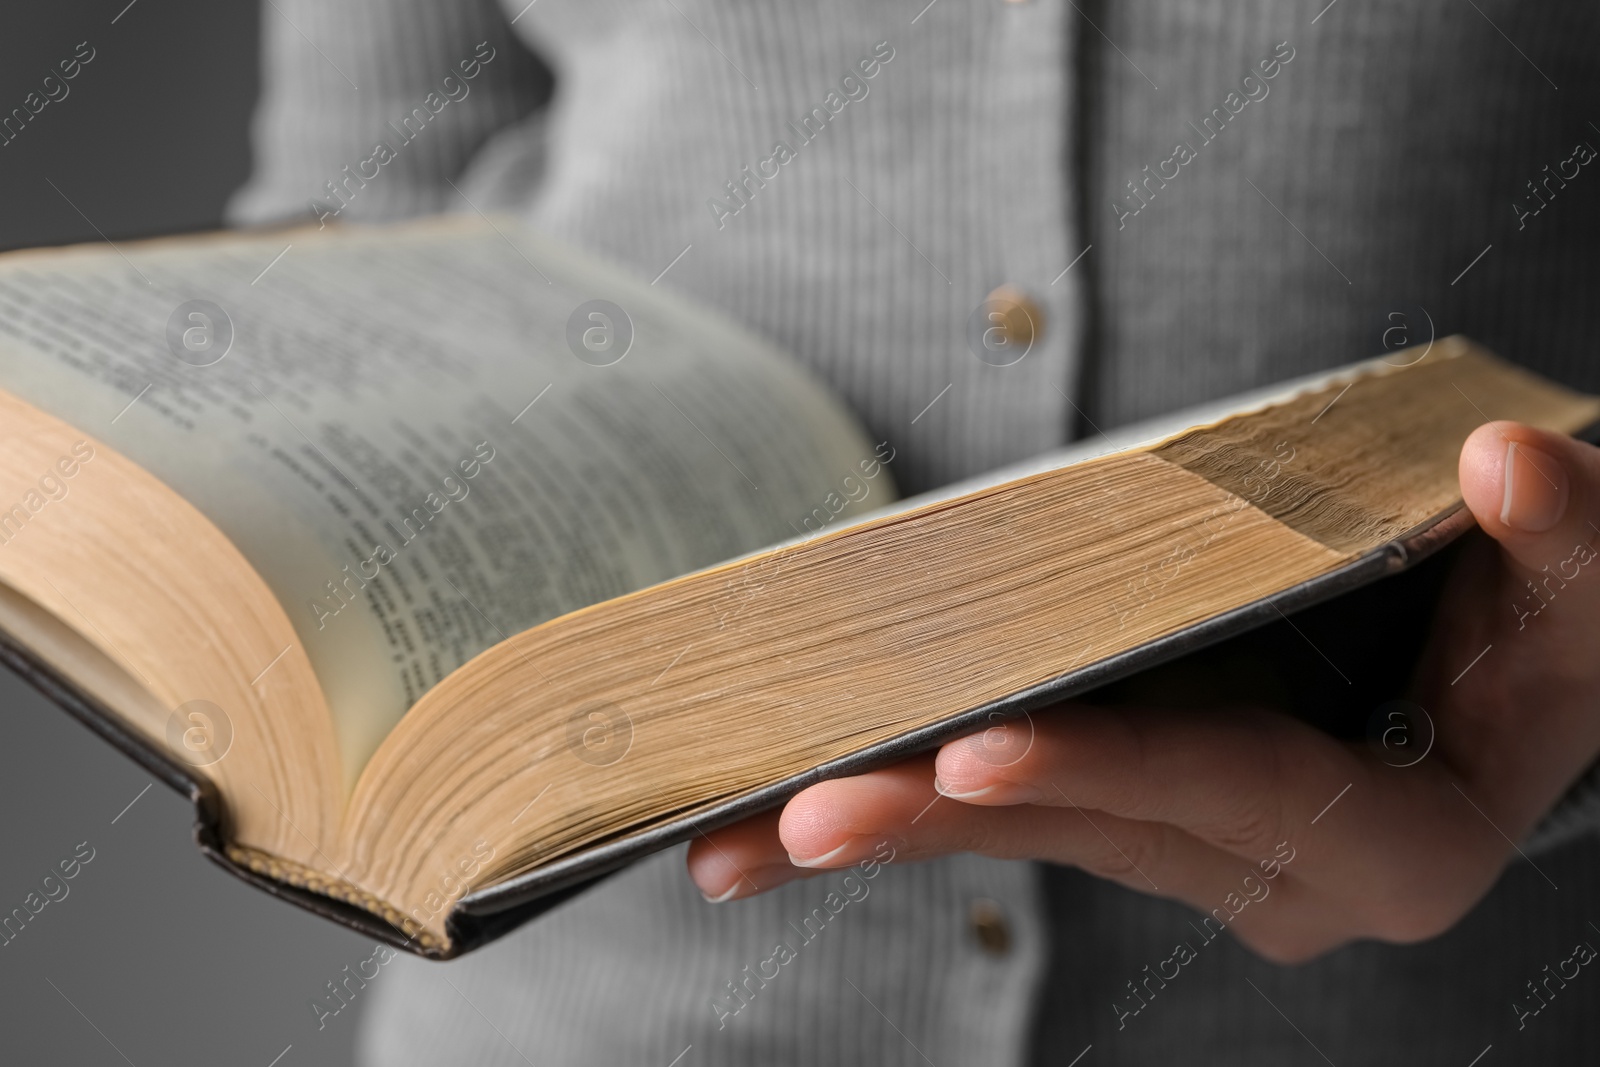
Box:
xmin=1459 ymin=422 xmax=1600 ymax=571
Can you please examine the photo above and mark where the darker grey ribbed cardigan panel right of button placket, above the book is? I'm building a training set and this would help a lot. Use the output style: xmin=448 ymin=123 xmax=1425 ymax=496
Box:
xmin=1080 ymin=0 xmax=1600 ymax=424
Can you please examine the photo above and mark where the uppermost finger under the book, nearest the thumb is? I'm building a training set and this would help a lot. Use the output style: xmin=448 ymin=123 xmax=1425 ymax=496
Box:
xmin=936 ymin=705 xmax=1365 ymax=857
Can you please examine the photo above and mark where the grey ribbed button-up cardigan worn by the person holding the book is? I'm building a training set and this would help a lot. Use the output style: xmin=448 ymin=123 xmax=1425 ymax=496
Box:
xmin=234 ymin=0 xmax=1600 ymax=1067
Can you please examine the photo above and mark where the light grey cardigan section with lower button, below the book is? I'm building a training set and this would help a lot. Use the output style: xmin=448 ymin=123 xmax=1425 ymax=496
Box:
xmin=362 ymin=849 xmax=1048 ymax=1067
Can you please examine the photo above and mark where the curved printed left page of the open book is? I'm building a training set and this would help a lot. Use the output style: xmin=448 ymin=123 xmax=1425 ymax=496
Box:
xmin=0 ymin=221 xmax=894 ymax=787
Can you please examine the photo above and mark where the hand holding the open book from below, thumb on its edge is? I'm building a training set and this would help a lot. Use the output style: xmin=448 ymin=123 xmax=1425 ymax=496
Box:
xmin=688 ymin=422 xmax=1600 ymax=961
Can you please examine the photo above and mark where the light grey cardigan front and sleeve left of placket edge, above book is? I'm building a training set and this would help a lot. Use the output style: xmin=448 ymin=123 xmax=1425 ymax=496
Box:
xmin=234 ymin=0 xmax=1082 ymax=490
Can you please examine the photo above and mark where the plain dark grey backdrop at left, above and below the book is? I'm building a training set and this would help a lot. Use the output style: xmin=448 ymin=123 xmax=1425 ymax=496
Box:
xmin=0 ymin=0 xmax=371 ymax=1067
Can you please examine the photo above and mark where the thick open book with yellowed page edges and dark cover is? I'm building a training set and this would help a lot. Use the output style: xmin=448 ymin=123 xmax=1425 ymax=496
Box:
xmin=0 ymin=221 xmax=1600 ymax=957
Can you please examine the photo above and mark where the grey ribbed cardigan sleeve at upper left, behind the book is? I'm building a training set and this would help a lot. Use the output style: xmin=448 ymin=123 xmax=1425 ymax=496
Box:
xmin=227 ymin=0 xmax=550 ymax=224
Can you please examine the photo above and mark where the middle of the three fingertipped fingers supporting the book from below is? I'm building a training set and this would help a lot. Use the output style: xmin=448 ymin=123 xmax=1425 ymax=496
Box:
xmin=779 ymin=758 xmax=1283 ymax=910
